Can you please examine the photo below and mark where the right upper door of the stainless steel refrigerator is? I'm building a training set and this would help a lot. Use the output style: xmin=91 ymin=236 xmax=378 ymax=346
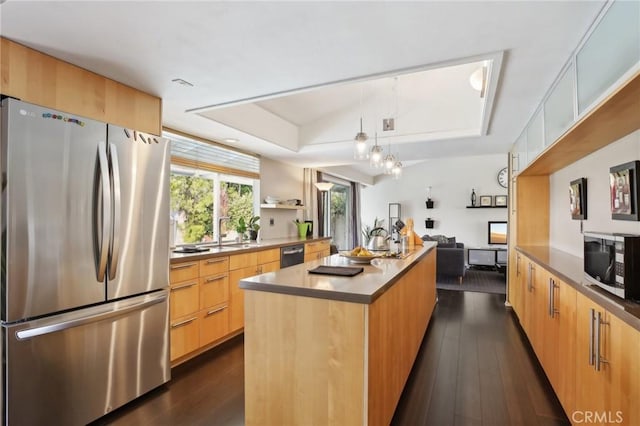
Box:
xmin=107 ymin=125 xmax=170 ymax=299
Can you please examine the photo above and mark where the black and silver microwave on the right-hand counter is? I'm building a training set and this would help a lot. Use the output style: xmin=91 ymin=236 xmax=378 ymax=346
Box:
xmin=584 ymin=232 xmax=640 ymax=300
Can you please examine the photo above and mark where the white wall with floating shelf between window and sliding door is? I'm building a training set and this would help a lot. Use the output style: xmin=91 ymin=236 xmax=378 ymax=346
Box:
xmin=260 ymin=157 xmax=304 ymax=240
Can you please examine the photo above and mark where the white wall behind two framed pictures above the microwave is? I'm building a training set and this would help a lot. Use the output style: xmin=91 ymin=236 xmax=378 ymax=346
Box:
xmin=549 ymin=130 xmax=640 ymax=257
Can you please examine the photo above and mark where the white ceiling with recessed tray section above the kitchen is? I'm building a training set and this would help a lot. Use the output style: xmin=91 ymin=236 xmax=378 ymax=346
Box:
xmin=0 ymin=0 xmax=604 ymax=180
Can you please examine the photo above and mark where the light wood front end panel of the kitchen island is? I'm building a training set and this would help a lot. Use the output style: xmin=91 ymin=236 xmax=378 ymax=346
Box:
xmin=244 ymin=290 xmax=366 ymax=426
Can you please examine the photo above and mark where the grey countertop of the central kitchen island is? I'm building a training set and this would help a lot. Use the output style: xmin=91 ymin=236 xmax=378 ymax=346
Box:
xmin=240 ymin=242 xmax=436 ymax=304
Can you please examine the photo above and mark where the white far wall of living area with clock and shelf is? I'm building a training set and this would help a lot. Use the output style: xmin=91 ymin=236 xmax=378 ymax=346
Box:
xmin=361 ymin=153 xmax=508 ymax=247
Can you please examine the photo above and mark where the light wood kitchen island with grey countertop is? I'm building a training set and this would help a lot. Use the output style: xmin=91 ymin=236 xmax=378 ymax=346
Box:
xmin=240 ymin=243 xmax=436 ymax=426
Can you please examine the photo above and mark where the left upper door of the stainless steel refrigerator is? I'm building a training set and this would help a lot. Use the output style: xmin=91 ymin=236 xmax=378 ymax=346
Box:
xmin=1 ymin=99 xmax=106 ymax=322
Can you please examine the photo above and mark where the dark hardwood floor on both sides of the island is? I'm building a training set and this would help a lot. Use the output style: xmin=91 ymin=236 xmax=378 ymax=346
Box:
xmin=94 ymin=290 xmax=570 ymax=426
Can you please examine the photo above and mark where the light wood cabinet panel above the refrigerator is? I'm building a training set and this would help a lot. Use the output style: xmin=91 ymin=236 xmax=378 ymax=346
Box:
xmin=0 ymin=38 xmax=162 ymax=135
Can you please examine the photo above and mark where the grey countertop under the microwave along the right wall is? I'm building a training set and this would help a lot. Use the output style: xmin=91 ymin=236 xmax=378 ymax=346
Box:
xmin=516 ymin=246 xmax=640 ymax=331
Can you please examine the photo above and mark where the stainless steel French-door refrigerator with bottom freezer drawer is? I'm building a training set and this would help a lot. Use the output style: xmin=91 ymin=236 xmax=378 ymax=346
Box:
xmin=0 ymin=99 xmax=170 ymax=425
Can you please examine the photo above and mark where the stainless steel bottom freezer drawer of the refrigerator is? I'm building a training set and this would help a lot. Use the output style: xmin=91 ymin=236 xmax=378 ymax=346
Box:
xmin=2 ymin=290 xmax=170 ymax=425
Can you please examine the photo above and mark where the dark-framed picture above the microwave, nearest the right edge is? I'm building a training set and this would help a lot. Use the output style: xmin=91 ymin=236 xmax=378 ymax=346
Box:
xmin=609 ymin=161 xmax=640 ymax=220
